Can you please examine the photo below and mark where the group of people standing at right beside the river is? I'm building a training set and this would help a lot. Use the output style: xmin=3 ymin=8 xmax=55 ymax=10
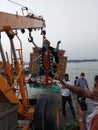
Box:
xmin=59 ymin=72 xmax=98 ymax=130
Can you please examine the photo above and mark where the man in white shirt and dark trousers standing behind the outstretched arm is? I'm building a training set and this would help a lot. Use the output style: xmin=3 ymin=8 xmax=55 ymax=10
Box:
xmin=61 ymin=74 xmax=76 ymax=119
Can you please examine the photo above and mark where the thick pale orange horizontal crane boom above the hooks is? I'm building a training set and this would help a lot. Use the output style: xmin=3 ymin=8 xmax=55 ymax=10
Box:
xmin=0 ymin=12 xmax=45 ymax=32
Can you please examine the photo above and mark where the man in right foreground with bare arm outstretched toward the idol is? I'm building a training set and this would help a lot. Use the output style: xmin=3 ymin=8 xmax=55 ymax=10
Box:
xmin=60 ymin=75 xmax=98 ymax=130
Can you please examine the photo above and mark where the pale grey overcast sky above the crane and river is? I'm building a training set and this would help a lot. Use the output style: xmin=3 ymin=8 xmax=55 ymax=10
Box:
xmin=0 ymin=0 xmax=98 ymax=61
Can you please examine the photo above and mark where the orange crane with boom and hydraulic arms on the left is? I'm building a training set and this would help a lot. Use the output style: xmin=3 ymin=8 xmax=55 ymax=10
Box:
xmin=0 ymin=12 xmax=45 ymax=130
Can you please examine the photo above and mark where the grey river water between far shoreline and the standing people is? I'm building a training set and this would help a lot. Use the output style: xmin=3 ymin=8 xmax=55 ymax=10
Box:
xmin=66 ymin=62 xmax=98 ymax=89
